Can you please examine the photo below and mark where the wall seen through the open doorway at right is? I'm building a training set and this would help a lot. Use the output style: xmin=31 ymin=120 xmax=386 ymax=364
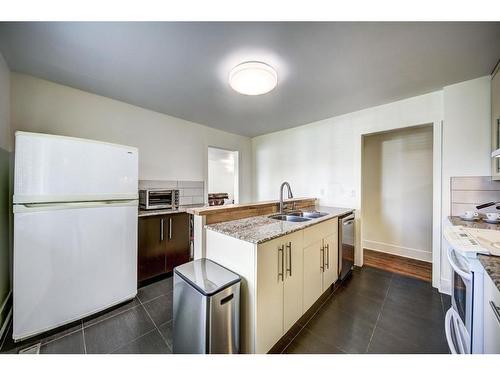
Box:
xmin=362 ymin=126 xmax=433 ymax=262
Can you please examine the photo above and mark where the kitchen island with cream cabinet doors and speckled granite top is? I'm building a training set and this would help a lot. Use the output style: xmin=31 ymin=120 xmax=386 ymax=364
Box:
xmin=205 ymin=206 xmax=353 ymax=353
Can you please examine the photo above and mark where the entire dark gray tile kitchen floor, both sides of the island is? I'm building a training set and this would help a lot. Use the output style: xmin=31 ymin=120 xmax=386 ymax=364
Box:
xmin=0 ymin=267 xmax=451 ymax=354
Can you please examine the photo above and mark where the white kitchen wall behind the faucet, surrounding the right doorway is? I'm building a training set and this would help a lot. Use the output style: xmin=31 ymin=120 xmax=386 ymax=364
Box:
xmin=252 ymin=77 xmax=490 ymax=290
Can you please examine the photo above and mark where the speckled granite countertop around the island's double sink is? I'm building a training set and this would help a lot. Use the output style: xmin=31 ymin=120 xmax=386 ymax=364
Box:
xmin=205 ymin=206 xmax=354 ymax=244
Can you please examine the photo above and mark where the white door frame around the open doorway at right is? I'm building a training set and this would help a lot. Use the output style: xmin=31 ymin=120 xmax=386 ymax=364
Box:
xmin=354 ymin=120 xmax=443 ymax=289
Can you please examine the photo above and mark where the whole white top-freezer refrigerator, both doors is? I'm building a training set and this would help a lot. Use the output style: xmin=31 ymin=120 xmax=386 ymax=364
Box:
xmin=13 ymin=132 xmax=138 ymax=341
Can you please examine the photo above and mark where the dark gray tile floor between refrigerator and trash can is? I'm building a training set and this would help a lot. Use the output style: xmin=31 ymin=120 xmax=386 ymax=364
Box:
xmin=0 ymin=277 xmax=173 ymax=354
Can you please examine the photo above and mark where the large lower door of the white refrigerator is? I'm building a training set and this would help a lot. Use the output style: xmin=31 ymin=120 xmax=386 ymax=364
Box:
xmin=13 ymin=201 xmax=137 ymax=340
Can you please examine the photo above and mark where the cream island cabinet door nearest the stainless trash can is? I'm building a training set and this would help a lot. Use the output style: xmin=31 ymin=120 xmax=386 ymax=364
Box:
xmin=255 ymin=238 xmax=285 ymax=353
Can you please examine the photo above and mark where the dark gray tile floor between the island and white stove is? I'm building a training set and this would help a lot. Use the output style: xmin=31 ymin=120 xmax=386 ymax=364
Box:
xmin=283 ymin=267 xmax=451 ymax=354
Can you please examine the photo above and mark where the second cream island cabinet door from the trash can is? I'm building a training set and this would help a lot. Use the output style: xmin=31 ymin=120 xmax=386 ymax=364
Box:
xmin=282 ymin=231 xmax=304 ymax=333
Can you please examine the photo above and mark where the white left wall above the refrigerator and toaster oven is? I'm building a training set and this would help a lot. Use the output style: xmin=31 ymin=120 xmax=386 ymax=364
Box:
xmin=11 ymin=73 xmax=252 ymax=202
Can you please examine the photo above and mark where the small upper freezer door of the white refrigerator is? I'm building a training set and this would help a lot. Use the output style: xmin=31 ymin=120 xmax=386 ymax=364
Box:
xmin=14 ymin=132 xmax=138 ymax=203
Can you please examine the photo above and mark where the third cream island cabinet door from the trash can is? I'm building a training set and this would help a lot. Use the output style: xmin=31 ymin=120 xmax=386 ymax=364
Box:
xmin=303 ymin=240 xmax=323 ymax=313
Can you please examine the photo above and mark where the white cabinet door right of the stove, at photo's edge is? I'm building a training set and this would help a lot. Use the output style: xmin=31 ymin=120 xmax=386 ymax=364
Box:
xmin=484 ymin=275 xmax=500 ymax=354
